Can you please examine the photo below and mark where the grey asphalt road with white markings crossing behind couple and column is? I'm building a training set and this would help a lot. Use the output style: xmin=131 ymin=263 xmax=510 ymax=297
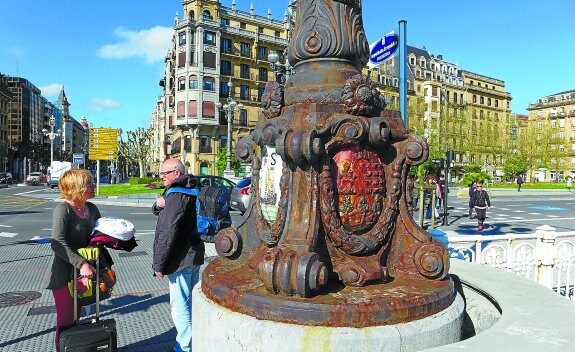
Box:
xmin=0 ymin=185 xmax=575 ymax=245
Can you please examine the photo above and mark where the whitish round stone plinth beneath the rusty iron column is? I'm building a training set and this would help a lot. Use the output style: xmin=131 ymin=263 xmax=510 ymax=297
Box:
xmin=192 ymin=285 xmax=464 ymax=352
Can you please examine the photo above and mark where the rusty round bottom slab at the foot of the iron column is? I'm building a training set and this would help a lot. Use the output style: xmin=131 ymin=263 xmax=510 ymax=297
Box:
xmin=202 ymin=258 xmax=455 ymax=328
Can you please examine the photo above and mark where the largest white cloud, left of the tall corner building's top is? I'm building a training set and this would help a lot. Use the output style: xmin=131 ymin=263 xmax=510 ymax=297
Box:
xmin=98 ymin=26 xmax=174 ymax=63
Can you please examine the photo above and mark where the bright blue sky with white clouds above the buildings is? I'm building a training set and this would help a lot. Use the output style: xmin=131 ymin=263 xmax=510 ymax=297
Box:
xmin=0 ymin=0 xmax=575 ymax=130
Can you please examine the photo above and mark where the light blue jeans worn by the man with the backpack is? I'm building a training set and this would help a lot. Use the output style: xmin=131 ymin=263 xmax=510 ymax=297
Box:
xmin=168 ymin=266 xmax=200 ymax=352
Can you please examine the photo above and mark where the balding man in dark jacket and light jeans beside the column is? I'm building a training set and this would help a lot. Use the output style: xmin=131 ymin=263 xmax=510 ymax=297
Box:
xmin=152 ymin=159 xmax=205 ymax=351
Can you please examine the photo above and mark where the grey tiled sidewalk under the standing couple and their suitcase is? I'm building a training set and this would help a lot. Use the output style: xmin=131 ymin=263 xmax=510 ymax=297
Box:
xmin=0 ymin=221 xmax=217 ymax=352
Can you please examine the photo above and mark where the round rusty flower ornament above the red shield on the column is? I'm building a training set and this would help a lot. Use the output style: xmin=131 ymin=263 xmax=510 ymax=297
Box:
xmin=342 ymin=74 xmax=385 ymax=116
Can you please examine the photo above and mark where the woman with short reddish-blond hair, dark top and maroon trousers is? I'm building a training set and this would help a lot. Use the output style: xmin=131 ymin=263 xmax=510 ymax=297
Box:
xmin=45 ymin=169 xmax=109 ymax=351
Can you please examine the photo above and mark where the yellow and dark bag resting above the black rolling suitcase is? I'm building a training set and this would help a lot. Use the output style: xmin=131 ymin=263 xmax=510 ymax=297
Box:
xmin=68 ymin=247 xmax=116 ymax=307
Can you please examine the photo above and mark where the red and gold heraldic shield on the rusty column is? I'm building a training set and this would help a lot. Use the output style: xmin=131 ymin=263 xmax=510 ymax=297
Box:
xmin=332 ymin=148 xmax=385 ymax=235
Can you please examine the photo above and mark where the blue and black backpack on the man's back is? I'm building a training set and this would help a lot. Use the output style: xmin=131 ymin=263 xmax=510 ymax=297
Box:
xmin=164 ymin=186 xmax=232 ymax=242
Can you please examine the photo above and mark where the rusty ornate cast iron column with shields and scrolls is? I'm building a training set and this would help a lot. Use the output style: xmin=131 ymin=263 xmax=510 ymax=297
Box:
xmin=202 ymin=0 xmax=455 ymax=327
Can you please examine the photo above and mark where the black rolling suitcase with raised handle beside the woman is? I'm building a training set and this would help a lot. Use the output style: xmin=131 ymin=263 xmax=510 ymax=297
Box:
xmin=59 ymin=250 xmax=118 ymax=352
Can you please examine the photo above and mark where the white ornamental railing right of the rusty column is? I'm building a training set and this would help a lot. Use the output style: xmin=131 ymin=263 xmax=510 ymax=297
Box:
xmin=446 ymin=225 xmax=575 ymax=302
